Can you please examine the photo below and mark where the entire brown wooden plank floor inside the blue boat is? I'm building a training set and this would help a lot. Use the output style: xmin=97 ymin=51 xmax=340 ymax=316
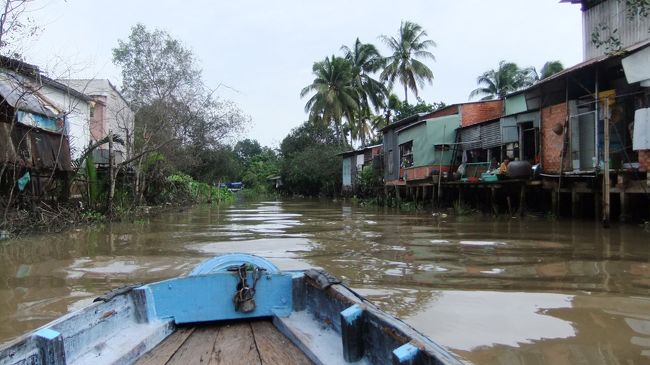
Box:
xmin=136 ymin=320 xmax=312 ymax=365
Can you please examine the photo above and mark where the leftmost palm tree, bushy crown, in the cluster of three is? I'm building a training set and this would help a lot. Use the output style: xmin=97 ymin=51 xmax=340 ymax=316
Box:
xmin=300 ymin=55 xmax=359 ymax=142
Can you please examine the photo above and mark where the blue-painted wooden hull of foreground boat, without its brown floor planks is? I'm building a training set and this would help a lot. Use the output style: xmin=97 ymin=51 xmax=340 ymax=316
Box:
xmin=0 ymin=256 xmax=466 ymax=365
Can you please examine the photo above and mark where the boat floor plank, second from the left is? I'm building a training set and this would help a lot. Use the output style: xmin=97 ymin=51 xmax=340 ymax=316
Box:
xmin=165 ymin=326 xmax=220 ymax=365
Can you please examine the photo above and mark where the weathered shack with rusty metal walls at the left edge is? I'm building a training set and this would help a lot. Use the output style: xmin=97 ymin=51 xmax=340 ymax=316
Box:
xmin=0 ymin=57 xmax=91 ymax=196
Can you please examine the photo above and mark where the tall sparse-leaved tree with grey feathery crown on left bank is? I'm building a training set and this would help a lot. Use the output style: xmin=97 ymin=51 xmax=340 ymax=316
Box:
xmin=113 ymin=24 xmax=248 ymax=200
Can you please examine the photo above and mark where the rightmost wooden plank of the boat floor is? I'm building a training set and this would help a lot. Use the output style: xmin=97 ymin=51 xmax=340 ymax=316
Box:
xmin=251 ymin=321 xmax=312 ymax=365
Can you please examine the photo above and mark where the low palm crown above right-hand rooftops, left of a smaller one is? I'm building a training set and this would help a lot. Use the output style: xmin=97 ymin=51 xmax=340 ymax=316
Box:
xmin=469 ymin=61 xmax=535 ymax=100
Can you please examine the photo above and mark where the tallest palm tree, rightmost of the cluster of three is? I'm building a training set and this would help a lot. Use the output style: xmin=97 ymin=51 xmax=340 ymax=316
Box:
xmin=380 ymin=21 xmax=436 ymax=103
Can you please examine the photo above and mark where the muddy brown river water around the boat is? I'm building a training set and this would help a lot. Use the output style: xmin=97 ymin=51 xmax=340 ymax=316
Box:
xmin=0 ymin=200 xmax=650 ymax=365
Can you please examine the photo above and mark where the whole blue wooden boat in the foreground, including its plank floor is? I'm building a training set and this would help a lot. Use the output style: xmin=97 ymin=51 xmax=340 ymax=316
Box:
xmin=0 ymin=254 xmax=466 ymax=365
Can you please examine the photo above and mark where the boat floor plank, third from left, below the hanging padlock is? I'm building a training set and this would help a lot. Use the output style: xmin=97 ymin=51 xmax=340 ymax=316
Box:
xmin=208 ymin=322 xmax=262 ymax=365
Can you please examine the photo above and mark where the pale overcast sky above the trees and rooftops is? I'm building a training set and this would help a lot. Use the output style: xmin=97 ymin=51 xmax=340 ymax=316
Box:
xmin=24 ymin=0 xmax=582 ymax=146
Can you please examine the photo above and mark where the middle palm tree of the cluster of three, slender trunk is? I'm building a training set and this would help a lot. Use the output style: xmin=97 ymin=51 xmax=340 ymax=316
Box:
xmin=341 ymin=38 xmax=388 ymax=145
